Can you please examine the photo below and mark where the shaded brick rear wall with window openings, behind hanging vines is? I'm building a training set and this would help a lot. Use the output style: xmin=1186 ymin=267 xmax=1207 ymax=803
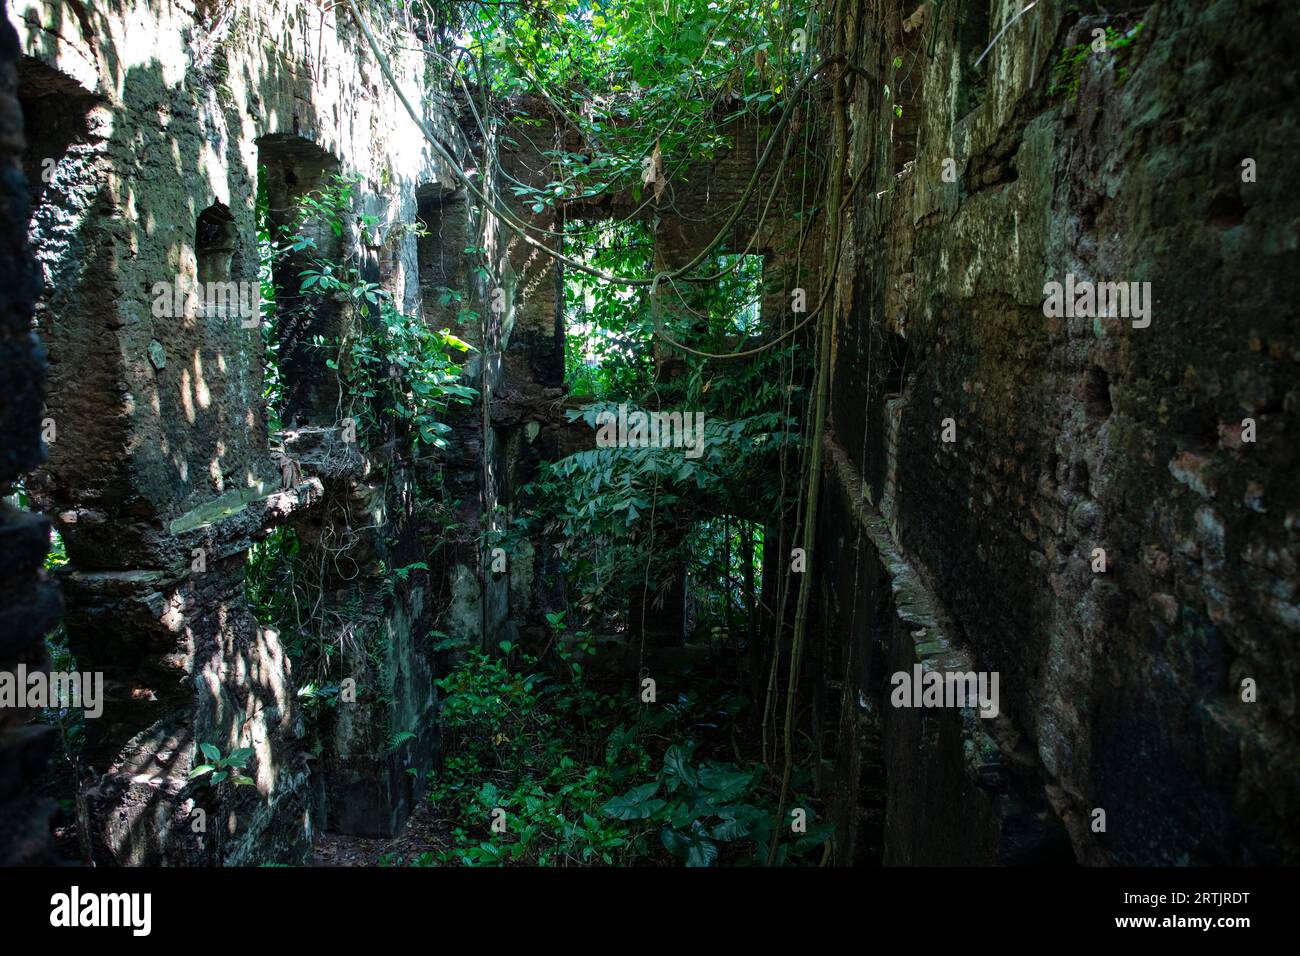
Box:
xmin=488 ymin=98 xmax=820 ymax=646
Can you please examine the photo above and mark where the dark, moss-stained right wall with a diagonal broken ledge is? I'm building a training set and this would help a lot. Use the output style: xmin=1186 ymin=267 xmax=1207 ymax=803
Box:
xmin=826 ymin=0 xmax=1300 ymax=864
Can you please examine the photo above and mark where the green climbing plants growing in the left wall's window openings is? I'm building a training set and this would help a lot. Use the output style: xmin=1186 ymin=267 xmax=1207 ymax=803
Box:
xmin=246 ymin=173 xmax=477 ymax=697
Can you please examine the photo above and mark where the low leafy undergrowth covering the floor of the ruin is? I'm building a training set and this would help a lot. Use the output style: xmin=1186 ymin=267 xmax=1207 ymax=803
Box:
xmin=426 ymin=629 xmax=828 ymax=866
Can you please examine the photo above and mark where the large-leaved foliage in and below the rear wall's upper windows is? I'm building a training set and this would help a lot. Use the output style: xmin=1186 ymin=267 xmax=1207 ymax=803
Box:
xmin=520 ymin=222 xmax=803 ymax=626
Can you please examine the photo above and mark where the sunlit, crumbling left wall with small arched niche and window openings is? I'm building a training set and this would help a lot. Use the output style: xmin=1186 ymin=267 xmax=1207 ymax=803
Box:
xmin=9 ymin=0 xmax=473 ymax=864
